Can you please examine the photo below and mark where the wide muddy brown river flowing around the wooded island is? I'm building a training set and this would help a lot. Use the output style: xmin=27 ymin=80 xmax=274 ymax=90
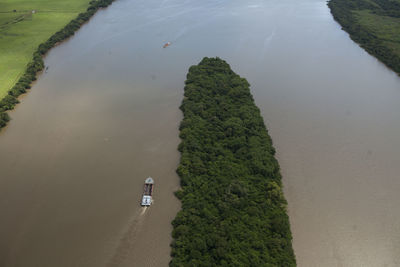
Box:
xmin=0 ymin=0 xmax=400 ymax=267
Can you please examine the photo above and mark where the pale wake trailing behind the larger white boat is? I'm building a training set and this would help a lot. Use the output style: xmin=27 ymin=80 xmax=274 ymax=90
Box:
xmin=107 ymin=207 xmax=147 ymax=267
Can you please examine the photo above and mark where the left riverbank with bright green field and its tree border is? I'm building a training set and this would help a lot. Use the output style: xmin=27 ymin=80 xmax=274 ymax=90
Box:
xmin=0 ymin=0 xmax=113 ymax=129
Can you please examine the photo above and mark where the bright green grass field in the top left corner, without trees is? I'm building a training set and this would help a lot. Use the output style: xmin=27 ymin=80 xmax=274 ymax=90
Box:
xmin=0 ymin=0 xmax=90 ymax=99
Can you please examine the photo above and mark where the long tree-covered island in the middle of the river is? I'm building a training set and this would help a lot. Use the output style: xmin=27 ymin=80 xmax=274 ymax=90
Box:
xmin=170 ymin=58 xmax=296 ymax=267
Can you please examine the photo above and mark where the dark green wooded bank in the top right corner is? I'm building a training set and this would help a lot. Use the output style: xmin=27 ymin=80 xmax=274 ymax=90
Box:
xmin=328 ymin=0 xmax=400 ymax=74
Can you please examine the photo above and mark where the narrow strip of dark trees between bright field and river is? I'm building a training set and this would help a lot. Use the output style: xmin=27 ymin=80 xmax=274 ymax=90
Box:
xmin=0 ymin=0 xmax=113 ymax=132
